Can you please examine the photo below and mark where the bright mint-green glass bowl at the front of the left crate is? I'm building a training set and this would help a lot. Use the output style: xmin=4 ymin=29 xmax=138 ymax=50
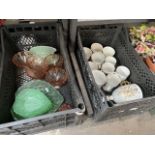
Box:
xmin=12 ymin=88 xmax=53 ymax=118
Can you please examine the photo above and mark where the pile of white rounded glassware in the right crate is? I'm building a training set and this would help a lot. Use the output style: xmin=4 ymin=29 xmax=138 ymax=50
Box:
xmin=83 ymin=43 xmax=143 ymax=104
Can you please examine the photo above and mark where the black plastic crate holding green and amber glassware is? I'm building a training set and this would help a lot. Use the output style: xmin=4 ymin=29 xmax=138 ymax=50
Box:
xmin=0 ymin=22 xmax=85 ymax=134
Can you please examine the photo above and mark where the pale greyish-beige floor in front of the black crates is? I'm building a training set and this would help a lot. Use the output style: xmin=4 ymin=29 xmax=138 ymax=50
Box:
xmin=40 ymin=112 xmax=155 ymax=135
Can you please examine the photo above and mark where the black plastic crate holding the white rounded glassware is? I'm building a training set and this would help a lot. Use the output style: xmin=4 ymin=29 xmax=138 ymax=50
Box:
xmin=76 ymin=22 xmax=155 ymax=120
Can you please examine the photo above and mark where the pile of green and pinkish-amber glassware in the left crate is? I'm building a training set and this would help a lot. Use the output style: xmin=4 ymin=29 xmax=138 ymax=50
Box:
xmin=11 ymin=46 xmax=72 ymax=120
